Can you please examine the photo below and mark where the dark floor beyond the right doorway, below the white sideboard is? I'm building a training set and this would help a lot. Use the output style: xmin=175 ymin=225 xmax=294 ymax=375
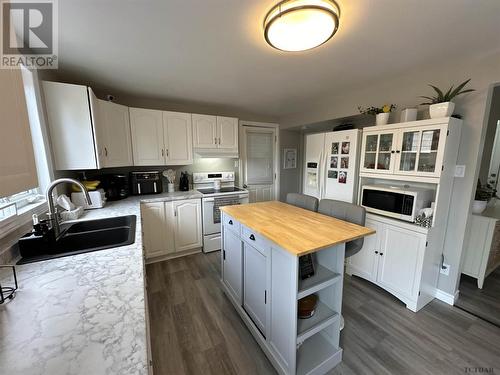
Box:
xmin=456 ymin=268 xmax=500 ymax=327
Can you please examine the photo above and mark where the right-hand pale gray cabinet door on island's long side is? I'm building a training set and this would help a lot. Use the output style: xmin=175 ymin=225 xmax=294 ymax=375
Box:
xmin=243 ymin=243 xmax=268 ymax=336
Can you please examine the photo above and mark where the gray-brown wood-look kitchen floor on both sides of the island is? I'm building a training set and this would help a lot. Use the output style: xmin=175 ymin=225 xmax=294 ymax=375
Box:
xmin=146 ymin=252 xmax=500 ymax=375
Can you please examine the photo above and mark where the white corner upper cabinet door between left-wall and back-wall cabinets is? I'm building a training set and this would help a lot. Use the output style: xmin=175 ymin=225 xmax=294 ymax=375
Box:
xmin=97 ymin=100 xmax=133 ymax=168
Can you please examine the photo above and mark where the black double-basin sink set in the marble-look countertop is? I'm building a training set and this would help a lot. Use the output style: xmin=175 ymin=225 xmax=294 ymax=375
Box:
xmin=17 ymin=215 xmax=136 ymax=264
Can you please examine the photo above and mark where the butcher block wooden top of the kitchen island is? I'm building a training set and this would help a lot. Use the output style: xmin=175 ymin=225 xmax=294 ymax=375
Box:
xmin=221 ymin=201 xmax=375 ymax=256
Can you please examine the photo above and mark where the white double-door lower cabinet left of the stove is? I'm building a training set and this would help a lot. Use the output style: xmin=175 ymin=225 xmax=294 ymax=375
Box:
xmin=141 ymin=199 xmax=202 ymax=259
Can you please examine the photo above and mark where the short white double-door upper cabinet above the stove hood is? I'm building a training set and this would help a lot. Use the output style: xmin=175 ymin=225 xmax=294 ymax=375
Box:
xmin=193 ymin=115 xmax=238 ymax=157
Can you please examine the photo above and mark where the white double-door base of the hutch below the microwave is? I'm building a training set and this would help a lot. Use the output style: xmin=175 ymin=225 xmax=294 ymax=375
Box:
xmin=347 ymin=219 xmax=426 ymax=310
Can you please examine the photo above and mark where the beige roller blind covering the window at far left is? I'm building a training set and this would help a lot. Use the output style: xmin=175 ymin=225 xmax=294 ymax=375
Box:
xmin=0 ymin=69 xmax=38 ymax=197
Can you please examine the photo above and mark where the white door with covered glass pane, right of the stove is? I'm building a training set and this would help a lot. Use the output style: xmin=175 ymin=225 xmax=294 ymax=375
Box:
xmin=241 ymin=126 xmax=276 ymax=203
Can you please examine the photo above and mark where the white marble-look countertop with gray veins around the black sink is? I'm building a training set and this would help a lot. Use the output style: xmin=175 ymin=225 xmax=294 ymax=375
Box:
xmin=0 ymin=191 xmax=201 ymax=375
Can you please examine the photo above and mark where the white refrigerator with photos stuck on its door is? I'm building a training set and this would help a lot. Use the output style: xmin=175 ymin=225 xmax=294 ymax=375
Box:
xmin=303 ymin=129 xmax=361 ymax=203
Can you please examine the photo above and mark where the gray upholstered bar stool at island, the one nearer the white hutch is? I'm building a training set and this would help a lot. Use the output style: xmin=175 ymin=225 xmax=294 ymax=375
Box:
xmin=318 ymin=199 xmax=366 ymax=330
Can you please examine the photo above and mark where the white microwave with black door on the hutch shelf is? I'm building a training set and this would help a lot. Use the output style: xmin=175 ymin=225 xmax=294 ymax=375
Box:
xmin=361 ymin=185 xmax=433 ymax=222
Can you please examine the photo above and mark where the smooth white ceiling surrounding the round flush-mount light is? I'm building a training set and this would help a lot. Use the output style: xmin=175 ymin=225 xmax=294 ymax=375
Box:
xmin=53 ymin=0 xmax=500 ymax=118
